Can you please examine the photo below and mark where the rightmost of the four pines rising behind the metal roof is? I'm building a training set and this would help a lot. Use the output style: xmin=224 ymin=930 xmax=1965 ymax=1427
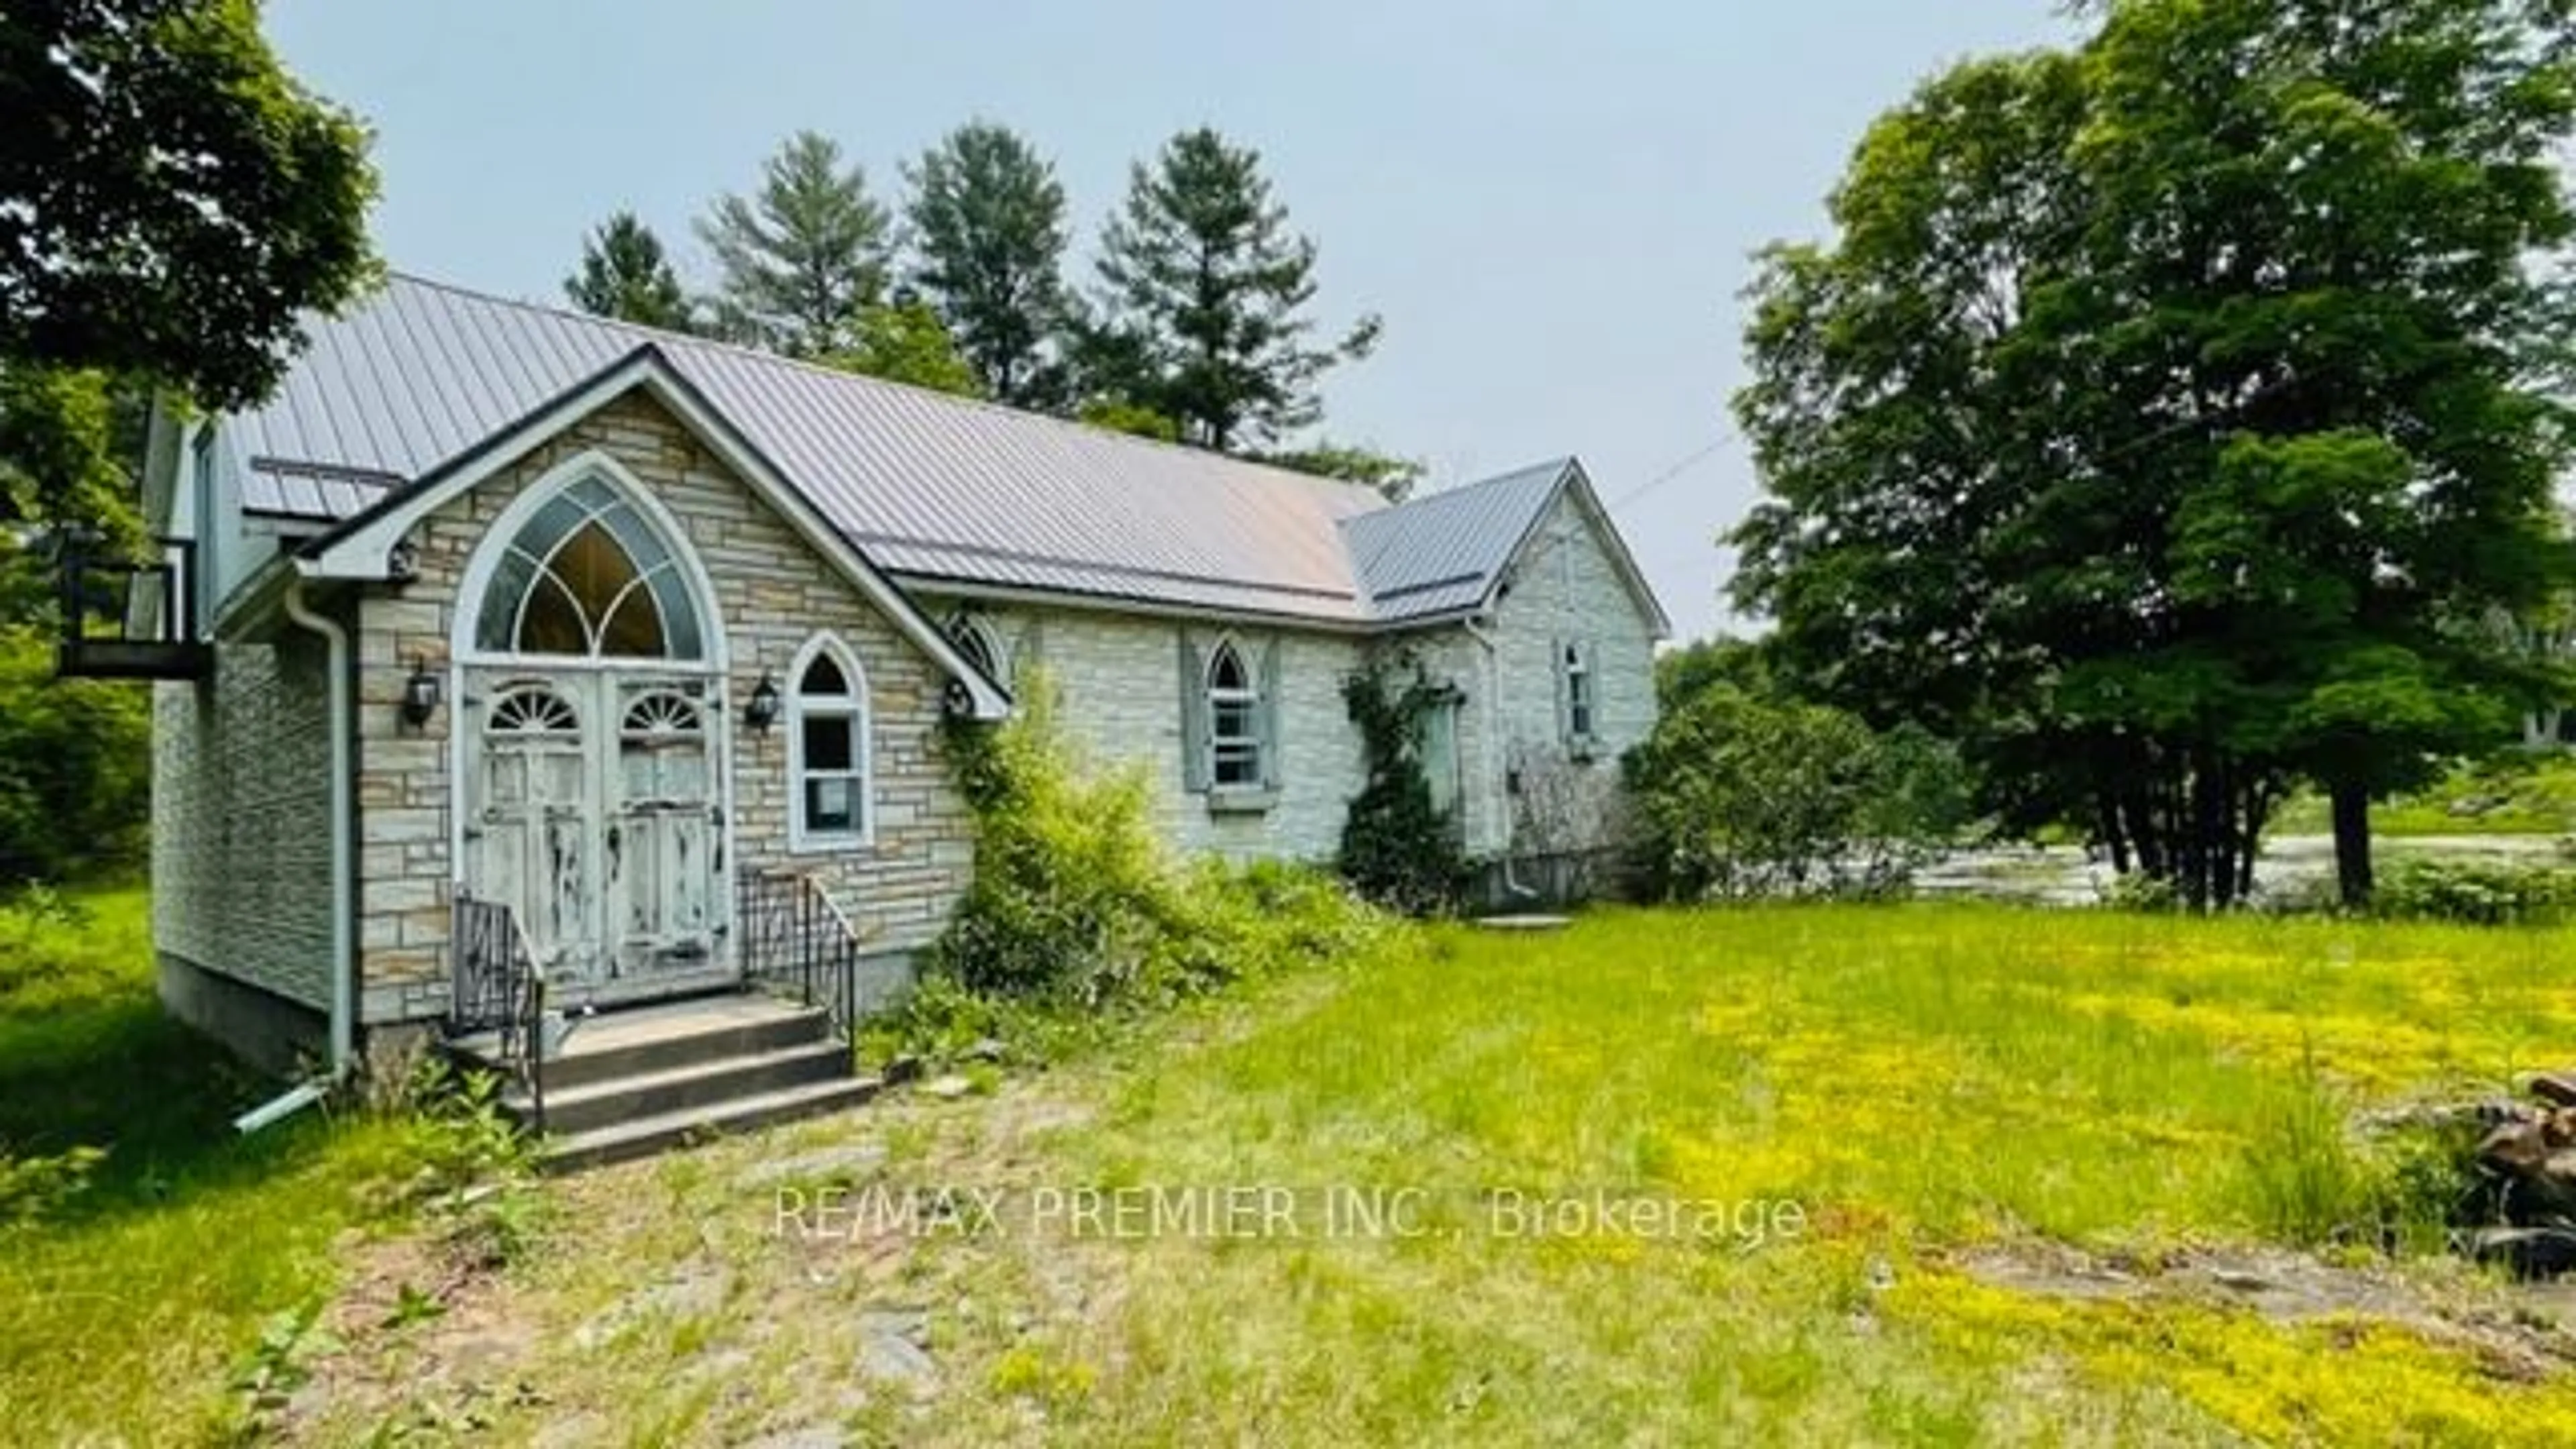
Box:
xmin=1085 ymin=126 xmax=1378 ymax=451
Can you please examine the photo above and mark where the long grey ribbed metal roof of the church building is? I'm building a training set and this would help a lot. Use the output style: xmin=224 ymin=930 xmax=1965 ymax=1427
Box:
xmin=224 ymin=273 xmax=1627 ymax=624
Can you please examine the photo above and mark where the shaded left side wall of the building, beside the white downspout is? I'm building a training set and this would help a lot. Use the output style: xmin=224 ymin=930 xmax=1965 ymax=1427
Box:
xmin=152 ymin=634 xmax=332 ymax=1008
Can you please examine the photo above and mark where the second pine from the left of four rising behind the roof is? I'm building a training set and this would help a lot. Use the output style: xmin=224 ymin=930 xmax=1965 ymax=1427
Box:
xmin=698 ymin=131 xmax=892 ymax=358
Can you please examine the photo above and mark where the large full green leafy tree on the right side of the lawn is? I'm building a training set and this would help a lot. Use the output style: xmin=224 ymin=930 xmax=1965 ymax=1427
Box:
xmin=1736 ymin=0 xmax=2576 ymax=902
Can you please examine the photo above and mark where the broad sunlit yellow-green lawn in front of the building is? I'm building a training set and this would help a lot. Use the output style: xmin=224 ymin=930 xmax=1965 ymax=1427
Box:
xmin=237 ymin=908 xmax=2576 ymax=1446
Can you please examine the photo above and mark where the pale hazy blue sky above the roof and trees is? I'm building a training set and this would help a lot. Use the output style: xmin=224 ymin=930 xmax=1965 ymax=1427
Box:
xmin=268 ymin=0 xmax=2061 ymax=637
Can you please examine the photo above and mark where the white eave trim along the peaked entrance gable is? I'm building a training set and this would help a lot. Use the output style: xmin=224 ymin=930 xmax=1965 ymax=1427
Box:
xmin=297 ymin=343 xmax=1010 ymax=719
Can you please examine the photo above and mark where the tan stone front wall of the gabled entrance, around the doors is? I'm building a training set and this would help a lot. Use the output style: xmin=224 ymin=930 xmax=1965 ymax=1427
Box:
xmin=356 ymin=392 xmax=974 ymax=1021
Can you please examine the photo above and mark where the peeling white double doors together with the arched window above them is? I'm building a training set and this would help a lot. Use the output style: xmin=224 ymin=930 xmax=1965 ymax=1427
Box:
xmin=456 ymin=461 xmax=732 ymax=1000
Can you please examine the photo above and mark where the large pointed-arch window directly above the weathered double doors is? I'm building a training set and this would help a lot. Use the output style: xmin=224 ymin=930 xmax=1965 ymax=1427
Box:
xmin=474 ymin=477 xmax=706 ymax=660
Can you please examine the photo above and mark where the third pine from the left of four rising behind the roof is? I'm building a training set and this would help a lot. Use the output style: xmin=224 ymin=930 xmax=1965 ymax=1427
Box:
xmin=904 ymin=121 xmax=1069 ymax=407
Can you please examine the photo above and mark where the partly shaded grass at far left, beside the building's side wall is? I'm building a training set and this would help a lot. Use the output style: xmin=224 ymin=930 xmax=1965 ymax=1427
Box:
xmin=0 ymin=890 xmax=482 ymax=1444
